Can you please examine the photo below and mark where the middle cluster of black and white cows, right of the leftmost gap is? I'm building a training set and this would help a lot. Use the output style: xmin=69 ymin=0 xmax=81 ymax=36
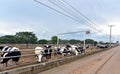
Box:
xmin=35 ymin=45 xmax=85 ymax=62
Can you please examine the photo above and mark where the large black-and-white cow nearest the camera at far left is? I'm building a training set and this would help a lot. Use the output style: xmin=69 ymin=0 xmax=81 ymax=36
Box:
xmin=0 ymin=46 xmax=21 ymax=66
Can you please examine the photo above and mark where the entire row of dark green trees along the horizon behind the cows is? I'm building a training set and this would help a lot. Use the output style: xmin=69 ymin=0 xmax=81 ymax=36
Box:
xmin=0 ymin=32 xmax=97 ymax=44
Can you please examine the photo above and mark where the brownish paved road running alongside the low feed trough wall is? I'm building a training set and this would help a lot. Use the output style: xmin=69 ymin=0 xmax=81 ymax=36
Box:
xmin=39 ymin=46 xmax=120 ymax=74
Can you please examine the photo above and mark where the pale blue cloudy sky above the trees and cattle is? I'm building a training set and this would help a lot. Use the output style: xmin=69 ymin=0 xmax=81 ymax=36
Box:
xmin=0 ymin=0 xmax=120 ymax=42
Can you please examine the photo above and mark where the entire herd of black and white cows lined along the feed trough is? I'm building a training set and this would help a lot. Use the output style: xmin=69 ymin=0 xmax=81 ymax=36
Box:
xmin=0 ymin=45 xmax=108 ymax=66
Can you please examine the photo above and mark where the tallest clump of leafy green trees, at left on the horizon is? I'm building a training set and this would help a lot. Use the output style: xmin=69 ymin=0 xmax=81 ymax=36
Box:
xmin=0 ymin=32 xmax=37 ymax=44
